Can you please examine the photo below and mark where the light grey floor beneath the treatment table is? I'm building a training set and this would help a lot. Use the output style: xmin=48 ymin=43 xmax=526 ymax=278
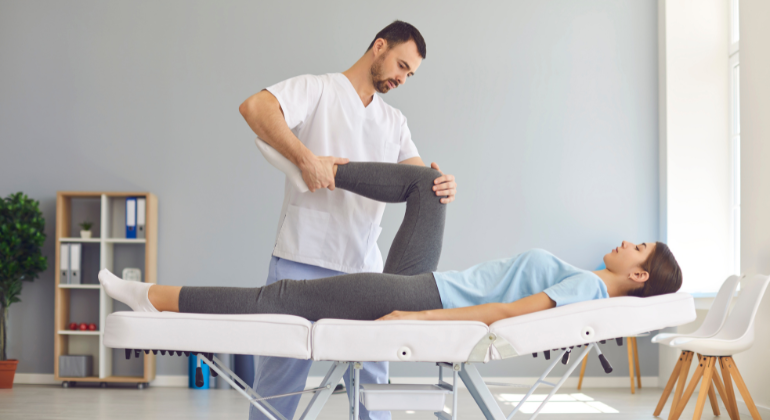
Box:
xmin=0 ymin=385 xmax=728 ymax=420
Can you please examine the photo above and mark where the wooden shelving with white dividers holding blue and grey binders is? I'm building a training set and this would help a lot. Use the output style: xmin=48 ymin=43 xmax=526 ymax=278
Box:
xmin=53 ymin=191 xmax=158 ymax=383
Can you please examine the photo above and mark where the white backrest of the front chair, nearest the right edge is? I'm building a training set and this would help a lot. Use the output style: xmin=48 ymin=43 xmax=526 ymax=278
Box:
xmin=715 ymin=274 xmax=770 ymax=340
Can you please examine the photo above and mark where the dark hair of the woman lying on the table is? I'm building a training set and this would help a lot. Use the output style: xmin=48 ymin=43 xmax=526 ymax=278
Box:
xmin=628 ymin=242 xmax=682 ymax=297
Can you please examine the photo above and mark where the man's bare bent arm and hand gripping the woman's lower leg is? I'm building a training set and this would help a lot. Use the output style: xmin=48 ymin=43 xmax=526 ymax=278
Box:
xmin=238 ymin=90 xmax=348 ymax=191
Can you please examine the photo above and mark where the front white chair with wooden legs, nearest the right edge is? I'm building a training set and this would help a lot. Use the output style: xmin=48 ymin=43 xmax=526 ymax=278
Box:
xmin=669 ymin=275 xmax=770 ymax=420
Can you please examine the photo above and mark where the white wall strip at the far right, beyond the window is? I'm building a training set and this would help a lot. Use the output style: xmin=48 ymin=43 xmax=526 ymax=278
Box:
xmin=735 ymin=0 xmax=770 ymax=410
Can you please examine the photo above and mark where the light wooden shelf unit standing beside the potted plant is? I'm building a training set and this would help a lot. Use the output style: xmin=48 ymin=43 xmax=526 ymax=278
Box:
xmin=54 ymin=191 xmax=158 ymax=384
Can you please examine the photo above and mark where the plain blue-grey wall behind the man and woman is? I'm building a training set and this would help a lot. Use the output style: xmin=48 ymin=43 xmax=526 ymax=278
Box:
xmin=0 ymin=0 xmax=658 ymax=378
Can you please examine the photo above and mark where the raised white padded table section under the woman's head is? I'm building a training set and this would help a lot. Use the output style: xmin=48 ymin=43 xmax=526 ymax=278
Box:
xmin=489 ymin=293 xmax=696 ymax=360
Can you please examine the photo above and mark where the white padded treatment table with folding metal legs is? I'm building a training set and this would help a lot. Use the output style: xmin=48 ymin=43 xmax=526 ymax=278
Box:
xmin=104 ymin=293 xmax=695 ymax=420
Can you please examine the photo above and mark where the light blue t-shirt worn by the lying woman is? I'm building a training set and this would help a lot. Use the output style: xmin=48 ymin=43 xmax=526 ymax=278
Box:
xmin=433 ymin=249 xmax=609 ymax=309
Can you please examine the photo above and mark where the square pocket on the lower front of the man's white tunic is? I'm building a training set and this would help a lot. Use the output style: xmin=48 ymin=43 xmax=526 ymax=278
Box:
xmin=276 ymin=205 xmax=331 ymax=258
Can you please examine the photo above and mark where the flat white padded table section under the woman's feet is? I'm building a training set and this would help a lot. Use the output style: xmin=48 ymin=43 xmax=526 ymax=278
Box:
xmin=104 ymin=312 xmax=312 ymax=359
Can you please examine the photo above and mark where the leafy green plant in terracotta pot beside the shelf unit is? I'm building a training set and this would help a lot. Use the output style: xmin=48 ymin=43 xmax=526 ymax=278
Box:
xmin=0 ymin=192 xmax=48 ymax=388
